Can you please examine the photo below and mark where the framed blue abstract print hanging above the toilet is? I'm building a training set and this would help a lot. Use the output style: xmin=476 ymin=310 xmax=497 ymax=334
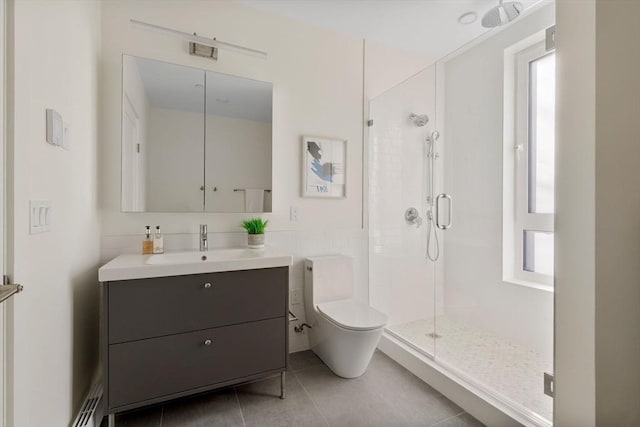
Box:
xmin=302 ymin=136 xmax=347 ymax=199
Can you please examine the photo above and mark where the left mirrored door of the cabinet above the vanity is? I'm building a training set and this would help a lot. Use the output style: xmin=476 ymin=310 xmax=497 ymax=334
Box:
xmin=122 ymin=55 xmax=205 ymax=212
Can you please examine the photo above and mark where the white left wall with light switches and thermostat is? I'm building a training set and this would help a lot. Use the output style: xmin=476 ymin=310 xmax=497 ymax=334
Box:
xmin=6 ymin=0 xmax=100 ymax=427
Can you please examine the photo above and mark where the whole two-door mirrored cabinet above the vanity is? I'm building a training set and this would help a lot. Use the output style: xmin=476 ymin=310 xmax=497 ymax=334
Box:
xmin=121 ymin=55 xmax=273 ymax=212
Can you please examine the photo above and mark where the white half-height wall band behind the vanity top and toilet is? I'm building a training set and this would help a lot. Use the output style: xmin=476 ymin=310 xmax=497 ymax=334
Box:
xmin=101 ymin=230 xmax=368 ymax=352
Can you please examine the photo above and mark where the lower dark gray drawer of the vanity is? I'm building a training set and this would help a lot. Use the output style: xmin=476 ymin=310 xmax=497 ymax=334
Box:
xmin=108 ymin=317 xmax=286 ymax=409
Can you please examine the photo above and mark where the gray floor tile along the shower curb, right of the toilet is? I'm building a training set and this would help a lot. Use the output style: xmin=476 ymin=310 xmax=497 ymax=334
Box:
xmin=362 ymin=351 xmax=464 ymax=426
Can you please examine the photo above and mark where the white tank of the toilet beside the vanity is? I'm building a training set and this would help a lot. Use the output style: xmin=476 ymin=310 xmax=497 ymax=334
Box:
xmin=304 ymin=255 xmax=354 ymax=306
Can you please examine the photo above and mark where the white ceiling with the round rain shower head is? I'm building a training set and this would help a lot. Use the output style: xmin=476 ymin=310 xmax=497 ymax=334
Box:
xmin=235 ymin=0 xmax=544 ymax=61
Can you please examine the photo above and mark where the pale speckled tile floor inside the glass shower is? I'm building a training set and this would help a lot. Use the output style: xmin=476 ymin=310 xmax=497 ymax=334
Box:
xmin=389 ymin=316 xmax=553 ymax=420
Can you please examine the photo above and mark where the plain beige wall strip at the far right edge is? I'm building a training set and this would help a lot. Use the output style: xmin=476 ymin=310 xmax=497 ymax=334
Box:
xmin=589 ymin=0 xmax=640 ymax=426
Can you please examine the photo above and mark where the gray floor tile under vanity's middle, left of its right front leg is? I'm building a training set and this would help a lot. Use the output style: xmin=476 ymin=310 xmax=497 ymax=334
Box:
xmin=162 ymin=388 xmax=244 ymax=427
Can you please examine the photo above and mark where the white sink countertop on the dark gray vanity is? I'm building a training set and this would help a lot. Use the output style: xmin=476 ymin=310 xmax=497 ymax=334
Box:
xmin=98 ymin=247 xmax=293 ymax=282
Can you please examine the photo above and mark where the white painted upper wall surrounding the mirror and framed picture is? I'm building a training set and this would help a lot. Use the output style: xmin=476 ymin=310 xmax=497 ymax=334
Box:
xmin=101 ymin=0 xmax=363 ymax=235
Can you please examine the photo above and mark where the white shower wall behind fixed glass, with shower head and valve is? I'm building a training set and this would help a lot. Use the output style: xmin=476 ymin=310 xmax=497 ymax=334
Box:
xmin=368 ymin=67 xmax=442 ymax=332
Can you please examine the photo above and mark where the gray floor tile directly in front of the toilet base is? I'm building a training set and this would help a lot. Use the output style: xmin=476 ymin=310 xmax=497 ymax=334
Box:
xmin=295 ymin=365 xmax=407 ymax=427
